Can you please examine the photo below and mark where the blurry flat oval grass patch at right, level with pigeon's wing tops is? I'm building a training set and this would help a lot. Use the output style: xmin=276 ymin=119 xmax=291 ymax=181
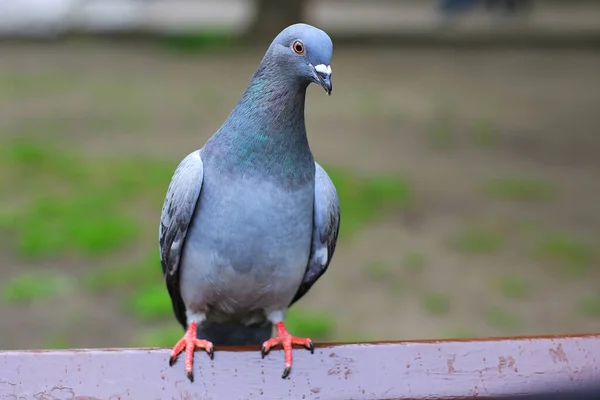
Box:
xmin=483 ymin=176 xmax=558 ymax=202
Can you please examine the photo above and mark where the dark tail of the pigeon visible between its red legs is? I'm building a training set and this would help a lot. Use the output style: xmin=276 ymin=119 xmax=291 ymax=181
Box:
xmin=197 ymin=322 xmax=273 ymax=346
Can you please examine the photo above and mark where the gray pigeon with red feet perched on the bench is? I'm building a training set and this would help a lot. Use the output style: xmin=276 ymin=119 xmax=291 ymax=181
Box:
xmin=159 ymin=24 xmax=340 ymax=381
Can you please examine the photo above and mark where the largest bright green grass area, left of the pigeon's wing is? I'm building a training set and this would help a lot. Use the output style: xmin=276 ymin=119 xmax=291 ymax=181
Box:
xmin=0 ymin=139 xmax=169 ymax=259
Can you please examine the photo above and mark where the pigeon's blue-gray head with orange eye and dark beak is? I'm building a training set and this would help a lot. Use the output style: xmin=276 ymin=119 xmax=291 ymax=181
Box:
xmin=266 ymin=24 xmax=333 ymax=95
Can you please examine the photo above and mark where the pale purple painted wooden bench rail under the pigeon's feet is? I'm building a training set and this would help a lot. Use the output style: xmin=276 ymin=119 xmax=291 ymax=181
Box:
xmin=0 ymin=334 xmax=600 ymax=400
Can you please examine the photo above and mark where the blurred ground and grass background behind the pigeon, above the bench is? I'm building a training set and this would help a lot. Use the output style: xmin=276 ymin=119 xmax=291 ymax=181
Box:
xmin=0 ymin=0 xmax=600 ymax=349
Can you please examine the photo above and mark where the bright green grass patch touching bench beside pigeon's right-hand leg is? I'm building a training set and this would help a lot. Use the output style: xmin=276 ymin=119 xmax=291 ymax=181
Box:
xmin=285 ymin=307 xmax=335 ymax=341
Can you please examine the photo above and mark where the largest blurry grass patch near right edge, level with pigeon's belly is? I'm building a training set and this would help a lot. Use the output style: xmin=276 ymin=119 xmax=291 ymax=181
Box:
xmin=533 ymin=232 xmax=596 ymax=276
